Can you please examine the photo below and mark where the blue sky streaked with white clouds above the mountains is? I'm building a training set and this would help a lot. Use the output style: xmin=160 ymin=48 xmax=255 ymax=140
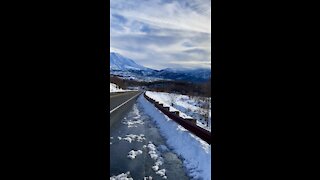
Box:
xmin=110 ymin=0 xmax=211 ymax=70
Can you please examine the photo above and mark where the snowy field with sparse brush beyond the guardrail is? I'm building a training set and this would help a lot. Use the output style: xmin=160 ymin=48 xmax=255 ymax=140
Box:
xmin=146 ymin=91 xmax=211 ymax=131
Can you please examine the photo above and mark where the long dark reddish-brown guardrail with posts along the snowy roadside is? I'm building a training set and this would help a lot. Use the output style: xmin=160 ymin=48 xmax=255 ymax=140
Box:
xmin=143 ymin=93 xmax=211 ymax=144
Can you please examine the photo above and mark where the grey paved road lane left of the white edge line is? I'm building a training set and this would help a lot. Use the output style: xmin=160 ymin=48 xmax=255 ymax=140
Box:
xmin=110 ymin=91 xmax=141 ymax=111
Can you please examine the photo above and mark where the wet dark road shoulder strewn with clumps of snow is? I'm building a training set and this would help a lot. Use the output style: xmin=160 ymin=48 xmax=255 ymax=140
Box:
xmin=110 ymin=95 xmax=189 ymax=180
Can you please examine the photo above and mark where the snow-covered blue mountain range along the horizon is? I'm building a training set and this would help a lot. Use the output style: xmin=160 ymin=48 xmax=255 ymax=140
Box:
xmin=110 ymin=52 xmax=211 ymax=83
